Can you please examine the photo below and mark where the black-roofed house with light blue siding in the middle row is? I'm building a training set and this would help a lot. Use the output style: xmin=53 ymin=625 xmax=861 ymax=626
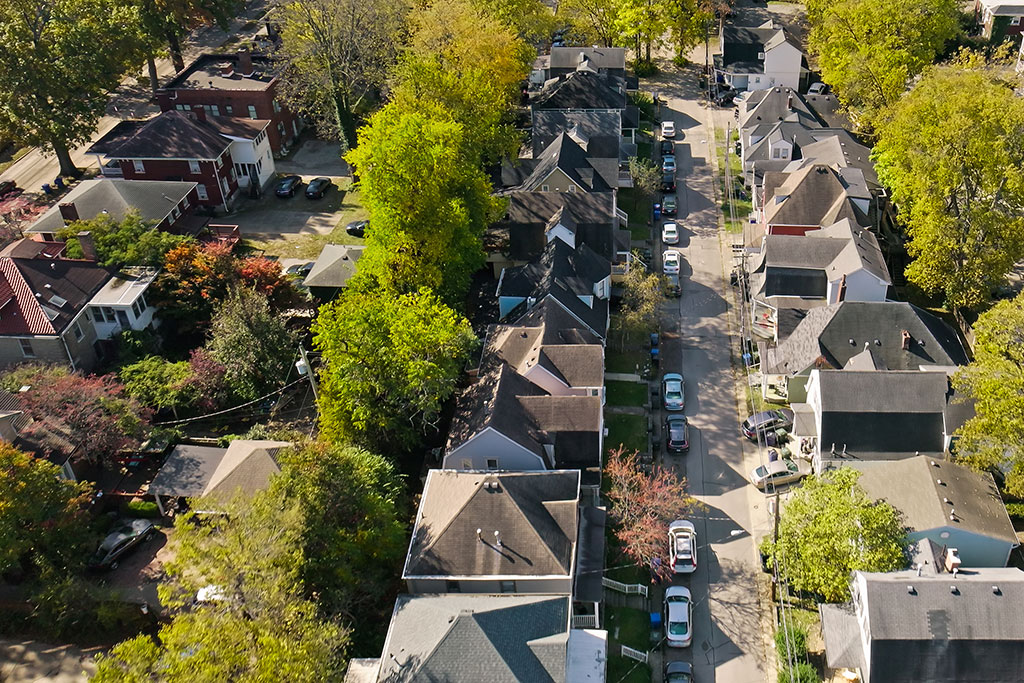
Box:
xmin=497 ymin=240 xmax=611 ymax=338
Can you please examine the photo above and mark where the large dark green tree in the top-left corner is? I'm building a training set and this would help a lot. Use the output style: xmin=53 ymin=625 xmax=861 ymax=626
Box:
xmin=0 ymin=0 xmax=144 ymax=176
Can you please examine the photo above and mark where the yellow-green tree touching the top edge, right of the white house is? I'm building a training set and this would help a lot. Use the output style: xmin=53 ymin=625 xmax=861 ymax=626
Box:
xmin=807 ymin=0 xmax=961 ymax=127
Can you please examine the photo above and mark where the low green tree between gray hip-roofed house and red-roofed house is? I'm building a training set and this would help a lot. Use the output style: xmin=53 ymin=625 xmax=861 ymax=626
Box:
xmin=57 ymin=209 xmax=190 ymax=269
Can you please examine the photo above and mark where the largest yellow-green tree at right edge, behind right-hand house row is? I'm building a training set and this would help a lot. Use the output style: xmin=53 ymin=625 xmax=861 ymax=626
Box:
xmin=874 ymin=57 xmax=1024 ymax=308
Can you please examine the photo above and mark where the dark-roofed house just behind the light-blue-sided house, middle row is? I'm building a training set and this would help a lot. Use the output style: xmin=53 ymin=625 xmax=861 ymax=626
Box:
xmin=483 ymin=193 xmax=631 ymax=278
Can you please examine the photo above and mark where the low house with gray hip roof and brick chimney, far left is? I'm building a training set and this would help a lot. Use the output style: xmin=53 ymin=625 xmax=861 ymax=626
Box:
xmin=26 ymin=178 xmax=199 ymax=242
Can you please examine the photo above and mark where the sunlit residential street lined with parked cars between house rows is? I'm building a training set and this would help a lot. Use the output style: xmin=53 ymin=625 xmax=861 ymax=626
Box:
xmin=645 ymin=58 xmax=768 ymax=683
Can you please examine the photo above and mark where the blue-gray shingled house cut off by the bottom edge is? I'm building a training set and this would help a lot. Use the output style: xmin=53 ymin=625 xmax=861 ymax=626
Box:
xmin=345 ymin=594 xmax=608 ymax=683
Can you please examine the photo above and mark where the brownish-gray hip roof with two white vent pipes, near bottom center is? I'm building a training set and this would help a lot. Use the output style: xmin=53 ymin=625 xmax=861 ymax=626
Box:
xmin=402 ymin=470 xmax=580 ymax=579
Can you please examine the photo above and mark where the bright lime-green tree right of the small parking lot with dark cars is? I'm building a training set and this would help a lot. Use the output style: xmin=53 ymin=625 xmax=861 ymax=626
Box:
xmin=346 ymin=102 xmax=500 ymax=303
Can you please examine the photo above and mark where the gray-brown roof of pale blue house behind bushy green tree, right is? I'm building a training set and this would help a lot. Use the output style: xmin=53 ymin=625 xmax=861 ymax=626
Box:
xmin=859 ymin=456 xmax=1017 ymax=545
